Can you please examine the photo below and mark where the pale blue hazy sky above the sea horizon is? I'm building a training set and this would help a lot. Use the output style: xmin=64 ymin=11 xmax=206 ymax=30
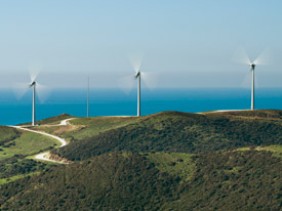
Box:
xmin=0 ymin=0 xmax=282 ymax=88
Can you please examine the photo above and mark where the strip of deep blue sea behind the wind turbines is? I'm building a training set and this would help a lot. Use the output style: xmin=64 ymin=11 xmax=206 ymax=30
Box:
xmin=0 ymin=88 xmax=282 ymax=125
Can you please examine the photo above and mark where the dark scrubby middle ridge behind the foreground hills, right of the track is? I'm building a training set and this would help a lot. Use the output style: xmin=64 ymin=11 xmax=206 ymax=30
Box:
xmin=56 ymin=112 xmax=282 ymax=160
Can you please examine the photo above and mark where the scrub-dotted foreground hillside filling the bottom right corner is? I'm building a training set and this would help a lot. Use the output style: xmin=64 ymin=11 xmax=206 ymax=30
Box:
xmin=165 ymin=150 xmax=282 ymax=210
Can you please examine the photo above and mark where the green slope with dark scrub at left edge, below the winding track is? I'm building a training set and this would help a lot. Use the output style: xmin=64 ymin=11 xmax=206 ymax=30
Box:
xmin=0 ymin=126 xmax=58 ymax=185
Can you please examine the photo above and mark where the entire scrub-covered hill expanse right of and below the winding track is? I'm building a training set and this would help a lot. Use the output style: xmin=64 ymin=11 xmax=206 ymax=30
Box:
xmin=0 ymin=111 xmax=282 ymax=210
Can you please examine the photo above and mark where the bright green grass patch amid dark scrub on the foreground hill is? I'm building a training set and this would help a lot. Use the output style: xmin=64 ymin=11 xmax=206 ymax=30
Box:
xmin=147 ymin=152 xmax=196 ymax=181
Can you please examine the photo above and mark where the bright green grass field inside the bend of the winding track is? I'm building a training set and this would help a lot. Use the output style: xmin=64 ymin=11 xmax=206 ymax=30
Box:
xmin=0 ymin=131 xmax=59 ymax=160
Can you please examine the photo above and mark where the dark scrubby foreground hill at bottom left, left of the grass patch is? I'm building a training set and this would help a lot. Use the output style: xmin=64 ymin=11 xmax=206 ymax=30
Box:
xmin=0 ymin=153 xmax=177 ymax=210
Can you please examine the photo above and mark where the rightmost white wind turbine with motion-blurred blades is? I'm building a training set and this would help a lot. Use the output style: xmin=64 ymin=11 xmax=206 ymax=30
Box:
xmin=235 ymin=49 xmax=270 ymax=111
